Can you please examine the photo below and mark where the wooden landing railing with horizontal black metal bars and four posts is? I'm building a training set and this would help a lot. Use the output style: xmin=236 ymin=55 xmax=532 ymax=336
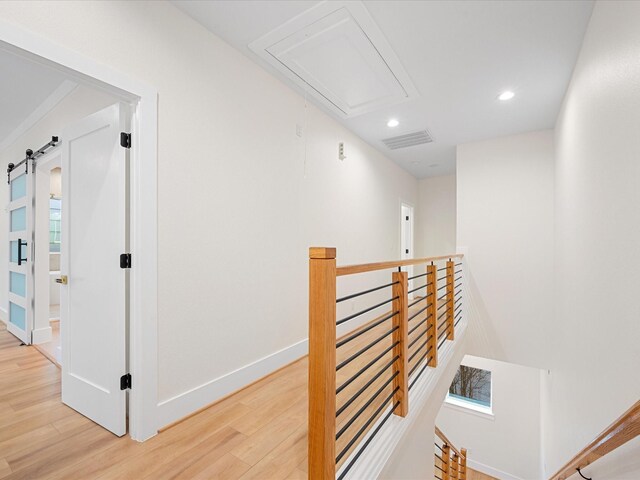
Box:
xmin=308 ymin=247 xmax=463 ymax=480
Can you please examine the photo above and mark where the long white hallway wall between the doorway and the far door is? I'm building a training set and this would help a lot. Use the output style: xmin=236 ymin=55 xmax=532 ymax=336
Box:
xmin=0 ymin=2 xmax=418 ymax=423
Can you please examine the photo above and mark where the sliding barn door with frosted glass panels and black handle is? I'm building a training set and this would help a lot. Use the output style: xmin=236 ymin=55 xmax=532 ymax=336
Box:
xmin=7 ymin=164 xmax=35 ymax=345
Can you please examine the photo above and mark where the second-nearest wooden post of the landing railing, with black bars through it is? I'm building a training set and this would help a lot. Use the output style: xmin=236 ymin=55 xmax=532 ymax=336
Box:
xmin=392 ymin=272 xmax=409 ymax=416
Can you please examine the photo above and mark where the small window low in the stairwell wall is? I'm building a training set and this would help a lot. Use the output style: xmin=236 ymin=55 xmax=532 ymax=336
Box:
xmin=446 ymin=365 xmax=493 ymax=415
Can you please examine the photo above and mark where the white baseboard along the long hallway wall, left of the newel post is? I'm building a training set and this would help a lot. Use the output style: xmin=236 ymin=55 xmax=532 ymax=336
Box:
xmin=158 ymin=340 xmax=309 ymax=428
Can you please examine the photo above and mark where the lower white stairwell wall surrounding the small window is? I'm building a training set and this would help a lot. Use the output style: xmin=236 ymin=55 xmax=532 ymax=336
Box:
xmin=436 ymin=355 xmax=542 ymax=480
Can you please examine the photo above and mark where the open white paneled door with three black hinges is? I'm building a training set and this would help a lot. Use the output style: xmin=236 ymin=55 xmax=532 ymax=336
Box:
xmin=60 ymin=104 xmax=128 ymax=436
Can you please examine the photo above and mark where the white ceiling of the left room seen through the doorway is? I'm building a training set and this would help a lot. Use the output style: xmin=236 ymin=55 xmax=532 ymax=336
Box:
xmin=0 ymin=49 xmax=75 ymax=150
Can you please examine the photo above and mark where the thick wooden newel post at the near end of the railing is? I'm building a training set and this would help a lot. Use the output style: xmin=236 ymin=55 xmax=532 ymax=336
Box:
xmin=309 ymin=247 xmax=336 ymax=480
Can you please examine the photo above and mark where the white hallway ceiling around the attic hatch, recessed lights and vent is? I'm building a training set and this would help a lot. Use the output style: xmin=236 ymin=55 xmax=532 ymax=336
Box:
xmin=173 ymin=0 xmax=593 ymax=177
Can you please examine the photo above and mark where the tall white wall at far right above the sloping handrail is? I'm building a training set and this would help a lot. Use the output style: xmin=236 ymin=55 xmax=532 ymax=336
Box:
xmin=543 ymin=1 xmax=640 ymax=478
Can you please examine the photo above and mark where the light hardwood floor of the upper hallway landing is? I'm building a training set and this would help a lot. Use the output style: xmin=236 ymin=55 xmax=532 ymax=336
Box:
xmin=0 ymin=292 xmax=450 ymax=480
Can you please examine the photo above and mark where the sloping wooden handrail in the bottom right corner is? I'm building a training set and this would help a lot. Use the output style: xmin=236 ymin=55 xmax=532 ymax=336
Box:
xmin=550 ymin=400 xmax=640 ymax=480
